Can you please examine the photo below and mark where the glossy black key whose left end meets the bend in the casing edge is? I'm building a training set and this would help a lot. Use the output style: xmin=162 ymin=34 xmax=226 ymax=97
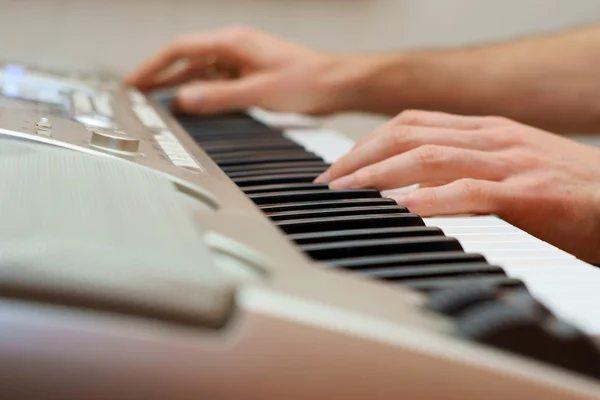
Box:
xmin=300 ymin=236 xmax=463 ymax=260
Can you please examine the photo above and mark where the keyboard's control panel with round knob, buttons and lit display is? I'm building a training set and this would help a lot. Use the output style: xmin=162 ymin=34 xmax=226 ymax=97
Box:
xmin=0 ymin=63 xmax=251 ymax=208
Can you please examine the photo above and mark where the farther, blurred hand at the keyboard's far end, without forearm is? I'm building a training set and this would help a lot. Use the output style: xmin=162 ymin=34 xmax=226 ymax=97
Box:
xmin=126 ymin=27 xmax=374 ymax=115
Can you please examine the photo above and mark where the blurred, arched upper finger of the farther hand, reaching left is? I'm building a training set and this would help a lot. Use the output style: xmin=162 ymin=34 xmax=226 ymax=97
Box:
xmin=125 ymin=32 xmax=249 ymax=87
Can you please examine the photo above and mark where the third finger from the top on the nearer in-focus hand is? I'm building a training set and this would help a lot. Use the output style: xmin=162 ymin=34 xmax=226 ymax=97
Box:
xmin=329 ymin=145 xmax=506 ymax=190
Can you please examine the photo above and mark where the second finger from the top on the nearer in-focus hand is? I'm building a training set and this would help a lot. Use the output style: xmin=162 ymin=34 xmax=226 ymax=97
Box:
xmin=315 ymin=125 xmax=494 ymax=183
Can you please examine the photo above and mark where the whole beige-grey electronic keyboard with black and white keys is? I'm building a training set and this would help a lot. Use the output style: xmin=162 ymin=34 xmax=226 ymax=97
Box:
xmin=0 ymin=64 xmax=600 ymax=400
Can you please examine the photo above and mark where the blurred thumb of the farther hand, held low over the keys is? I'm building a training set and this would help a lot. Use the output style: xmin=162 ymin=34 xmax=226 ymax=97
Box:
xmin=174 ymin=77 xmax=266 ymax=114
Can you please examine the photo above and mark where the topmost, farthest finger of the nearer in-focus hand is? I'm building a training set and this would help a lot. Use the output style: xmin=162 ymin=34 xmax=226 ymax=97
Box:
xmin=357 ymin=110 xmax=503 ymax=146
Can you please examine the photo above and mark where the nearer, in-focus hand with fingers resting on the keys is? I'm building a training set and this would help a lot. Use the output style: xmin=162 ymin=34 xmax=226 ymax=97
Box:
xmin=317 ymin=111 xmax=600 ymax=263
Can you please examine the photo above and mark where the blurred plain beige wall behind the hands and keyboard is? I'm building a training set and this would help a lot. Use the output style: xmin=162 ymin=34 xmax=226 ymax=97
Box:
xmin=0 ymin=0 xmax=600 ymax=141
